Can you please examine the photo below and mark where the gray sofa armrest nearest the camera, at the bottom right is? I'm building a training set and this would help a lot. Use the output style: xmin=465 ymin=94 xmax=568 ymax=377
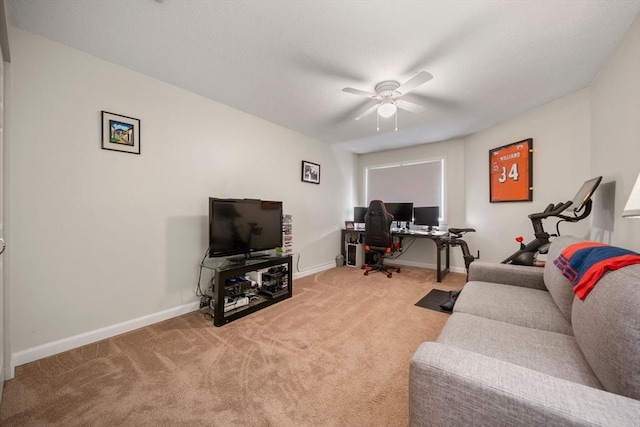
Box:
xmin=409 ymin=342 xmax=640 ymax=427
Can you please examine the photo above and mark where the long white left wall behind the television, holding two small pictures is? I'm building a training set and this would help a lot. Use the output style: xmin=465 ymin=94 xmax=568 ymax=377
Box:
xmin=8 ymin=30 xmax=355 ymax=361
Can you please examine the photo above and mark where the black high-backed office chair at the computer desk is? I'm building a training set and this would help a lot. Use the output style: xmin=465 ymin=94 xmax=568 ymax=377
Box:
xmin=362 ymin=200 xmax=400 ymax=278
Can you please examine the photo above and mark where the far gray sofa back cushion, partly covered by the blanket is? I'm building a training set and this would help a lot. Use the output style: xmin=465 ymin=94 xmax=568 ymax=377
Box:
xmin=544 ymin=236 xmax=583 ymax=322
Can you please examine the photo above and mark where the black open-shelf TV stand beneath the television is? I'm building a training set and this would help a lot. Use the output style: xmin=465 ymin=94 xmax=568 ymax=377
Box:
xmin=213 ymin=255 xmax=293 ymax=326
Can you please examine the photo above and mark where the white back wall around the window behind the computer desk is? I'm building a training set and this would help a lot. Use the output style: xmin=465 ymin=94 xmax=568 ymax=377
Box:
xmin=356 ymin=139 xmax=466 ymax=272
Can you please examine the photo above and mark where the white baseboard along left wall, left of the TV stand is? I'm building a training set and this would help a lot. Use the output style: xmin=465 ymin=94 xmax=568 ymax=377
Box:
xmin=5 ymin=301 xmax=200 ymax=379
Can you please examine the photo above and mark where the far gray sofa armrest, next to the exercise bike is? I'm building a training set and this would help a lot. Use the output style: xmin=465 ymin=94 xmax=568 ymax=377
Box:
xmin=469 ymin=261 xmax=547 ymax=290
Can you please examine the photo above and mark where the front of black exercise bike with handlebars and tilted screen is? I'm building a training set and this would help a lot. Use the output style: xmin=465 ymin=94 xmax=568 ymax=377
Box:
xmin=502 ymin=176 xmax=602 ymax=266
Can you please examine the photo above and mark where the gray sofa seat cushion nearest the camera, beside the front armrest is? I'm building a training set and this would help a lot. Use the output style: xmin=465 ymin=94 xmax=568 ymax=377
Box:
xmin=436 ymin=313 xmax=602 ymax=388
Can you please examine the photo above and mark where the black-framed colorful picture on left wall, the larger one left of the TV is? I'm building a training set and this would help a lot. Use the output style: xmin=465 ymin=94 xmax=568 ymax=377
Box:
xmin=102 ymin=111 xmax=140 ymax=154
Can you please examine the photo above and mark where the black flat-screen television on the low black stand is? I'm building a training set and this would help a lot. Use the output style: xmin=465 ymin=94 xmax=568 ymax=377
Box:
xmin=209 ymin=197 xmax=282 ymax=257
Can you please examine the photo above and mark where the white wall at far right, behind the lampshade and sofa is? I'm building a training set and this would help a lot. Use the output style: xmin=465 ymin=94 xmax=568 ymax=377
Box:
xmin=591 ymin=15 xmax=640 ymax=251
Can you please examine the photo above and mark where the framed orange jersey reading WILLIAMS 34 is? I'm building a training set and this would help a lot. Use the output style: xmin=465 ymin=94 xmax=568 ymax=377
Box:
xmin=489 ymin=138 xmax=533 ymax=203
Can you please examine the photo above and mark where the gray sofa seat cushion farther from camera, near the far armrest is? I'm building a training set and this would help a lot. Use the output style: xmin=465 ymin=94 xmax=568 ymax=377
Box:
xmin=453 ymin=282 xmax=573 ymax=335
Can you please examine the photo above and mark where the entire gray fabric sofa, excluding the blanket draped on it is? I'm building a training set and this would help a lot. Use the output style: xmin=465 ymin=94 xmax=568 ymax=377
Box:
xmin=409 ymin=236 xmax=640 ymax=426
